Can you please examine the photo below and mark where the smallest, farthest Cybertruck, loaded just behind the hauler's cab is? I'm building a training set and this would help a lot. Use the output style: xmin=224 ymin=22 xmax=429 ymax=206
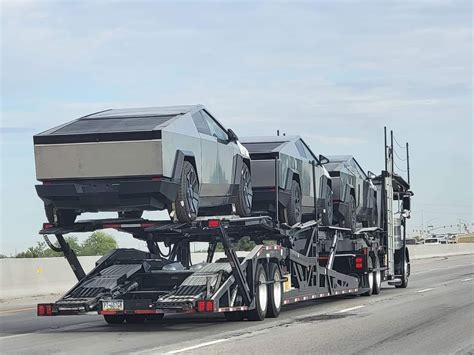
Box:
xmin=326 ymin=155 xmax=378 ymax=230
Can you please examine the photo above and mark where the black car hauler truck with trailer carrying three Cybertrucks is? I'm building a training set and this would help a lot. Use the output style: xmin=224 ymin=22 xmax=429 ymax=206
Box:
xmin=37 ymin=129 xmax=412 ymax=323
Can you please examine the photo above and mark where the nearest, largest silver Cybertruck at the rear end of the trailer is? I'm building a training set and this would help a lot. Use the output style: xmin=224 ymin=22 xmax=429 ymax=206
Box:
xmin=34 ymin=105 xmax=252 ymax=225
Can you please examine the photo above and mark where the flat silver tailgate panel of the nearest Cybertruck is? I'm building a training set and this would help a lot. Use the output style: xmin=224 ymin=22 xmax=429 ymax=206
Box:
xmin=34 ymin=140 xmax=163 ymax=180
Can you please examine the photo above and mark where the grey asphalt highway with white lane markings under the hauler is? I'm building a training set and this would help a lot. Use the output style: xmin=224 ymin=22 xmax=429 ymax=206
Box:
xmin=0 ymin=255 xmax=474 ymax=355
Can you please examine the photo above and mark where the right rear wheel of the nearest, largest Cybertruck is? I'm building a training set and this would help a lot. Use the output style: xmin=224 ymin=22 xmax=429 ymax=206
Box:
xmin=175 ymin=161 xmax=199 ymax=223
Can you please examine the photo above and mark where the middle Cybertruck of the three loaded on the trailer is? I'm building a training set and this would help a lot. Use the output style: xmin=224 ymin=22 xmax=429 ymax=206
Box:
xmin=241 ymin=136 xmax=333 ymax=225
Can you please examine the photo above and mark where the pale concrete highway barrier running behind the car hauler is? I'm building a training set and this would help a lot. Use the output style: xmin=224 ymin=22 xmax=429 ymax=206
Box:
xmin=0 ymin=248 xmax=474 ymax=300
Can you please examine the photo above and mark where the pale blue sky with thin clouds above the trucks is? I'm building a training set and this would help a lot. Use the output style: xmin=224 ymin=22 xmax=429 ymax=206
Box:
xmin=0 ymin=0 xmax=474 ymax=255
